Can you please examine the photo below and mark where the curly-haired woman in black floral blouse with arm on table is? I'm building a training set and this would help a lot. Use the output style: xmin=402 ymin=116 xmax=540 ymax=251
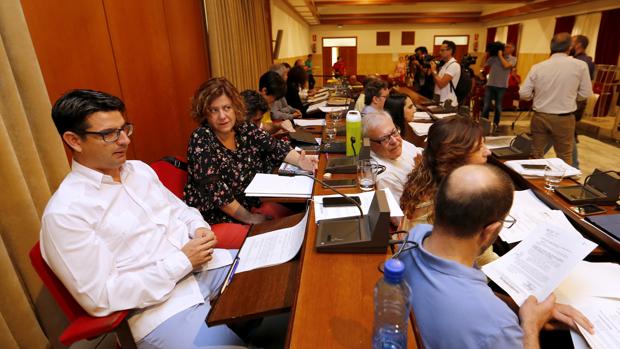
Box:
xmin=185 ymin=78 xmax=318 ymax=248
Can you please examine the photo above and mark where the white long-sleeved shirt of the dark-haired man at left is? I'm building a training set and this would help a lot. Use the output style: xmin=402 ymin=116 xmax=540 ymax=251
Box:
xmin=41 ymin=161 xmax=209 ymax=341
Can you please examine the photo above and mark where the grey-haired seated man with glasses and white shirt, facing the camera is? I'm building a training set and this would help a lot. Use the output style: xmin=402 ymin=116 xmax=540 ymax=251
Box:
xmin=364 ymin=112 xmax=422 ymax=202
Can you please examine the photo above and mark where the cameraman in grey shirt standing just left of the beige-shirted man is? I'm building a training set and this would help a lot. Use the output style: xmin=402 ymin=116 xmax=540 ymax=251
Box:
xmin=482 ymin=41 xmax=517 ymax=132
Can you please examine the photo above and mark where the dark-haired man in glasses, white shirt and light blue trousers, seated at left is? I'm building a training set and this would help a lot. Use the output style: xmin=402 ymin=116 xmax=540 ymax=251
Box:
xmin=41 ymin=90 xmax=243 ymax=348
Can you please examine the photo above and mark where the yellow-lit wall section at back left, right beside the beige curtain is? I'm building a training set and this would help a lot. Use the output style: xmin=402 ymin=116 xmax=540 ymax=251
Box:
xmin=270 ymin=0 xmax=310 ymax=59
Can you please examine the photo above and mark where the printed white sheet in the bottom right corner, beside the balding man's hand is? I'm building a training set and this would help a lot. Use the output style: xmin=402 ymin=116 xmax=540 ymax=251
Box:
xmin=575 ymin=297 xmax=620 ymax=349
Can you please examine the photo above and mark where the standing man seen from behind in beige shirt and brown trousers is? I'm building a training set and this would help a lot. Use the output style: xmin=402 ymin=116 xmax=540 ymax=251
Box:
xmin=519 ymin=33 xmax=592 ymax=165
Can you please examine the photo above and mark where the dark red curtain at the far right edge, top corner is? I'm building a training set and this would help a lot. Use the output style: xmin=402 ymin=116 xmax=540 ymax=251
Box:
xmin=595 ymin=8 xmax=620 ymax=65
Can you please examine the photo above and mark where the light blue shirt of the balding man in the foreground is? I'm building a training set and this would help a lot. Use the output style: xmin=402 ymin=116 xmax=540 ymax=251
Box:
xmin=400 ymin=224 xmax=523 ymax=349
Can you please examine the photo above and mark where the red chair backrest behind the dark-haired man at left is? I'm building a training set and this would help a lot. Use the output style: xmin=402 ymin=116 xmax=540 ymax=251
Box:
xmin=29 ymin=241 xmax=86 ymax=321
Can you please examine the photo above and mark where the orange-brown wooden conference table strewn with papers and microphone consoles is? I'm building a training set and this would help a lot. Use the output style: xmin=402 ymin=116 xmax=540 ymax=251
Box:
xmin=207 ymin=91 xmax=620 ymax=348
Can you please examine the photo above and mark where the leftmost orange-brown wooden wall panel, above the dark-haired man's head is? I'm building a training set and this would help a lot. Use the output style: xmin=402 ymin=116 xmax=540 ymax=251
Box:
xmin=21 ymin=0 xmax=135 ymax=157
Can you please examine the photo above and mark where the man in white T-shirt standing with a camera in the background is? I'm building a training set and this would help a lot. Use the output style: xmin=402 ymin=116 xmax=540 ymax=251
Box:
xmin=431 ymin=40 xmax=461 ymax=108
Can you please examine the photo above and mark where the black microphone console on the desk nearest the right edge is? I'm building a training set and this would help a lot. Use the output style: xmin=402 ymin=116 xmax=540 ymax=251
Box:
xmin=555 ymin=169 xmax=620 ymax=205
